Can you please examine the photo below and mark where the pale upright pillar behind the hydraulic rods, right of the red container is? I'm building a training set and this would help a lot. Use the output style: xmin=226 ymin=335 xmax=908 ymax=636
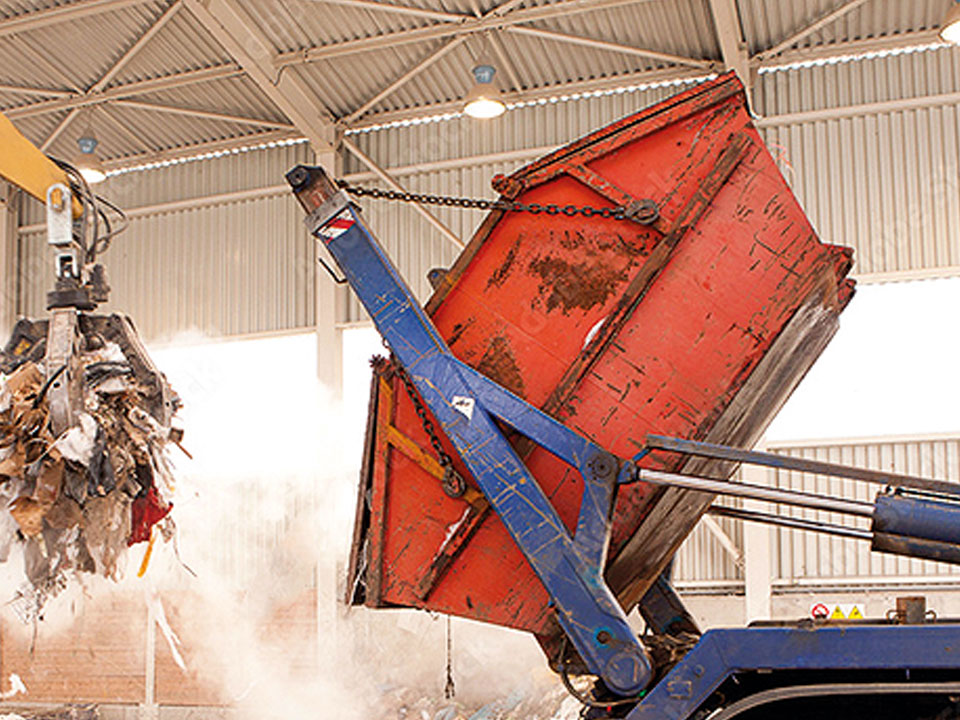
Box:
xmin=740 ymin=441 xmax=773 ymax=623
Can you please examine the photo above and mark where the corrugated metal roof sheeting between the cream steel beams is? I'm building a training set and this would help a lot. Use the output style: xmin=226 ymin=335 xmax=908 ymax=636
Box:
xmin=0 ymin=0 xmax=954 ymax=164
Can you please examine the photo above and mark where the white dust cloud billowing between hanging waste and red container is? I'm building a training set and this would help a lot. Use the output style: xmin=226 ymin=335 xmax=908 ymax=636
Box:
xmin=3 ymin=334 xmax=578 ymax=720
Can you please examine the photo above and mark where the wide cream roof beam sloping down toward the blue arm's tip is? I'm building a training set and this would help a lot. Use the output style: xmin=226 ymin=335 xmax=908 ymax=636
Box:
xmin=185 ymin=0 xmax=336 ymax=153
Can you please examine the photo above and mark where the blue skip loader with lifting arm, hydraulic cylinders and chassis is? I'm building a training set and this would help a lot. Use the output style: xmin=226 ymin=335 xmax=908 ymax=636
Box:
xmin=287 ymin=166 xmax=960 ymax=720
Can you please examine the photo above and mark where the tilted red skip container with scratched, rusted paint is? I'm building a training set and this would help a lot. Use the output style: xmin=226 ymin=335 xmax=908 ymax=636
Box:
xmin=349 ymin=75 xmax=853 ymax=644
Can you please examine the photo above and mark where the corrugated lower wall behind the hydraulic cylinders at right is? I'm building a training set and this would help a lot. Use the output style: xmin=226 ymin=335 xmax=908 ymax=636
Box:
xmin=675 ymin=436 xmax=960 ymax=588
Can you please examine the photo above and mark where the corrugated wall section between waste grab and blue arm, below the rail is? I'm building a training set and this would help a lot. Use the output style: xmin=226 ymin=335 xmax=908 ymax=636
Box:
xmin=19 ymin=193 xmax=315 ymax=342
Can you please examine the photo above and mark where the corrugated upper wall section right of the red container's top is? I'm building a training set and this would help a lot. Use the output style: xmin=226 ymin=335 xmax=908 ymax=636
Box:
xmin=764 ymin=104 xmax=960 ymax=278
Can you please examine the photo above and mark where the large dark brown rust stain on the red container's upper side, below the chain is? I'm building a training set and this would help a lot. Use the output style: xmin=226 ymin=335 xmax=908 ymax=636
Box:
xmin=530 ymin=257 xmax=627 ymax=314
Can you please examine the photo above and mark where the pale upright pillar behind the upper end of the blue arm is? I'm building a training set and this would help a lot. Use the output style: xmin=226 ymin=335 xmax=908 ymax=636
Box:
xmin=314 ymin=145 xmax=347 ymax=400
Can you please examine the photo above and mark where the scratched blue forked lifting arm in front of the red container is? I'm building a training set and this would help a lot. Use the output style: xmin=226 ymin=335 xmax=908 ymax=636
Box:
xmin=287 ymin=166 xmax=652 ymax=695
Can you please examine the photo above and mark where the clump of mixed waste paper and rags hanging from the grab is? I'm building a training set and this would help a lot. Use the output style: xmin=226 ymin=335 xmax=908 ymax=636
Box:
xmin=0 ymin=315 xmax=182 ymax=622
